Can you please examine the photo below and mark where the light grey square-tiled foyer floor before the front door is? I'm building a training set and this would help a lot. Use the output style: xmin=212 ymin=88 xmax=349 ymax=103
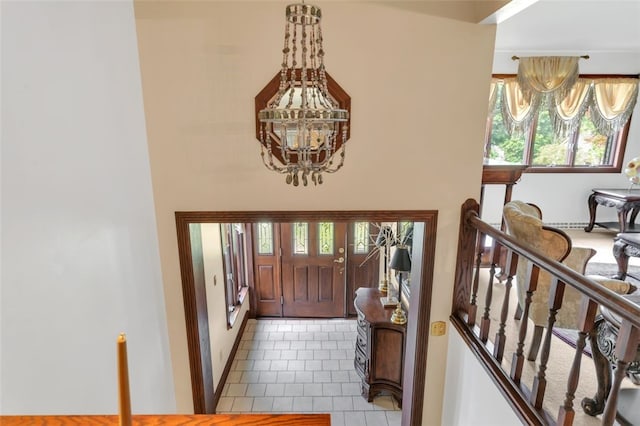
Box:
xmin=217 ymin=319 xmax=401 ymax=426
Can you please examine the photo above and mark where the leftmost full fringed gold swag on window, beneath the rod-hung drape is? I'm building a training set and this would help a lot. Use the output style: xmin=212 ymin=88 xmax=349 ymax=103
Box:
xmin=502 ymin=78 xmax=540 ymax=135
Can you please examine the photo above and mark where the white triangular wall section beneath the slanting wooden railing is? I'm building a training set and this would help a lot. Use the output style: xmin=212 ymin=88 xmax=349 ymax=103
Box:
xmin=442 ymin=327 xmax=522 ymax=426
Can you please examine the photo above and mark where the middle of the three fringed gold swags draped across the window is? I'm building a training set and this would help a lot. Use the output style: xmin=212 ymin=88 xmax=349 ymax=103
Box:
xmin=549 ymin=78 xmax=591 ymax=138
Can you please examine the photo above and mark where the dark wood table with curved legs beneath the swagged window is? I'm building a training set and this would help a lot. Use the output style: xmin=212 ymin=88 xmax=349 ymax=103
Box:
xmin=584 ymin=189 xmax=640 ymax=232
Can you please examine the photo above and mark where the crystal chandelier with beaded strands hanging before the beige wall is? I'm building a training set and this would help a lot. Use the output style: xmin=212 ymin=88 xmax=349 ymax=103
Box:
xmin=258 ymin=3 xmax=349 ymax=186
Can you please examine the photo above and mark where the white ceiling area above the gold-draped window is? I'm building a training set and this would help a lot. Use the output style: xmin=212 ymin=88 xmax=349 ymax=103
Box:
xmin=496 ymin=0 xmax=640 ymax=55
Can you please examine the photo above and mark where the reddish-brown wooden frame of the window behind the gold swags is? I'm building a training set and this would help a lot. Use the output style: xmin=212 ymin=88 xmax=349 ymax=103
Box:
xmin=484 ymin=74 xmax=638 ymax=173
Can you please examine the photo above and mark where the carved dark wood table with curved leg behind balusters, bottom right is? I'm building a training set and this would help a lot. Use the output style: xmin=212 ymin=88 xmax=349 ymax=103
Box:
xmin=582 ymin=294 xmax=640 ymax=426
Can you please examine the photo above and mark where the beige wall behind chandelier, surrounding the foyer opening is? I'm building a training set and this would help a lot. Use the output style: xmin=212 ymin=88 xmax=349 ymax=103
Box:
xmin=135 ymin=1 xmax=495 ymax=424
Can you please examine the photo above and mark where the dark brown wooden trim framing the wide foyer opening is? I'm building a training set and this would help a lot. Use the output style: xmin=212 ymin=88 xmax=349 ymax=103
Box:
xmin=175 ymin=210 xmax=438 ymax=426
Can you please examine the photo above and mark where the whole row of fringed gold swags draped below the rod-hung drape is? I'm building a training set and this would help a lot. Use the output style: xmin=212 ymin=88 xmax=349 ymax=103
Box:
xmin=500 ymin=75 xmax=638 ymax=137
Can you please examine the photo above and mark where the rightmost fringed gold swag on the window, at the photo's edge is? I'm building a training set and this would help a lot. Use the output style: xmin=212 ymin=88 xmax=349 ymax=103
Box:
xmin=591 ymin=78 xmax=638 ymax=136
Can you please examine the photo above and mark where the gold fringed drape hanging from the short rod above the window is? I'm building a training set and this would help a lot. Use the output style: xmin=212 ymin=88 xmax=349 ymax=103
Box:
xmin=518 ymin=56 xmax=580 ymax=100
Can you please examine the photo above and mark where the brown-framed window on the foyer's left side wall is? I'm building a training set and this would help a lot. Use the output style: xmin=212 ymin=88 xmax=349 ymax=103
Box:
xmin=220 ymin=223 xmax=247 ymax=326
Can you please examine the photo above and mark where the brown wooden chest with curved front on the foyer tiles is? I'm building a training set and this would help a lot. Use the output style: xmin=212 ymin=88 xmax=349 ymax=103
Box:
xmin=353 ymin=287 xmax=407 ymax=407
